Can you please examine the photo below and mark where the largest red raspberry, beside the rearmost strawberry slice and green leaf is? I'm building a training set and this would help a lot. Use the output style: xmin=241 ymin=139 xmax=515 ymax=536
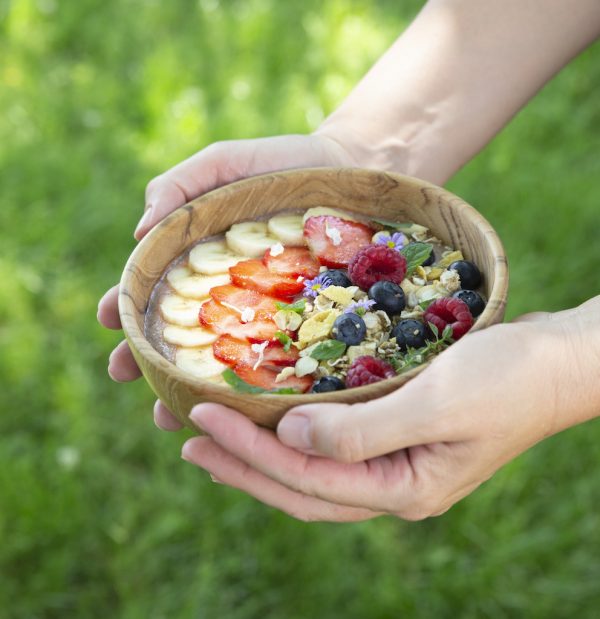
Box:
xmin=348 ymin=245 xmax=406 ymax=290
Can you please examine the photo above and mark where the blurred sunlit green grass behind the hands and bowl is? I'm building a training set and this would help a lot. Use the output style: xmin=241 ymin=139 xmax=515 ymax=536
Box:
xmin=0 ymin=0 xmax=600 ymax=619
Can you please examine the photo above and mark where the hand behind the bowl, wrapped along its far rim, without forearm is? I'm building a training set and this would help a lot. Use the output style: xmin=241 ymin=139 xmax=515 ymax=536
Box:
xmin=98 ymin=134 xmax=357 ymax=382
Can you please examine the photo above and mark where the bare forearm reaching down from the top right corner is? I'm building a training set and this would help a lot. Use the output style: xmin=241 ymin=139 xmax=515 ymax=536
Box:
xmin=317 ymin=0 xmax=600 ymax=184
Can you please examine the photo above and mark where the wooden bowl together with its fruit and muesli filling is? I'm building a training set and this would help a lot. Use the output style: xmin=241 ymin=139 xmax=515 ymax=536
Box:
xmin=119 ymin=168 xmax=508 ymax=428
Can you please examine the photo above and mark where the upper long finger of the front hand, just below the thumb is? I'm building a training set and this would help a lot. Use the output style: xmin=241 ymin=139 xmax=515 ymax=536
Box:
xmin=190 ymin=404 xmax=415 ymax=512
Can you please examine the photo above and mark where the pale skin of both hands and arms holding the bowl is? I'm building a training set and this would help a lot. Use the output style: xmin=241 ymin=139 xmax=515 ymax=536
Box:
xmin=98 ymin=0 xmax=600 ymax=521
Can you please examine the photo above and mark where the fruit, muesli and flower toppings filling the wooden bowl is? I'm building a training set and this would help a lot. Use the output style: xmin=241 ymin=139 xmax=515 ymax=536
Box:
xmin=150 ymin=207 xmax=485 ymax=393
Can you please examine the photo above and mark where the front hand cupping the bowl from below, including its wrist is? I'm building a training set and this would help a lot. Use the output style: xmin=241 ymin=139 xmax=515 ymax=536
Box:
xmin=178 ymin=298 xmax=600 ymax=521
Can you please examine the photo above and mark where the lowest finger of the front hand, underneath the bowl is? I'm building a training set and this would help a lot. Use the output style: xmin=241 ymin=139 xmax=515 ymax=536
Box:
xmin=182 ymin=436 xmax=379 ymax=522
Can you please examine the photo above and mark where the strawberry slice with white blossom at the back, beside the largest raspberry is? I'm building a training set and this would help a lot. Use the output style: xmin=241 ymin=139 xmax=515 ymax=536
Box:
xmin=304 ymin=215 xmax=374 ymax=269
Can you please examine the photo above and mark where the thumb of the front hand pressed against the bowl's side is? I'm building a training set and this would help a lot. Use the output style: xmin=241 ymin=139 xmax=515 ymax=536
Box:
xmin=277 ymin=368 xmax=456 ymax=463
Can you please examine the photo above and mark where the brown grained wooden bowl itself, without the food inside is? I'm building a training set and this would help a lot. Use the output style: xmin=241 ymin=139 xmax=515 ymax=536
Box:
xmin=119 ymin=168 xmax=508 ymax=429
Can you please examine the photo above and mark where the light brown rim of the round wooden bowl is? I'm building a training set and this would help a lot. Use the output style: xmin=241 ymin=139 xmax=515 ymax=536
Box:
xmin=118 ymin=167 xmax=508 ymax=406
